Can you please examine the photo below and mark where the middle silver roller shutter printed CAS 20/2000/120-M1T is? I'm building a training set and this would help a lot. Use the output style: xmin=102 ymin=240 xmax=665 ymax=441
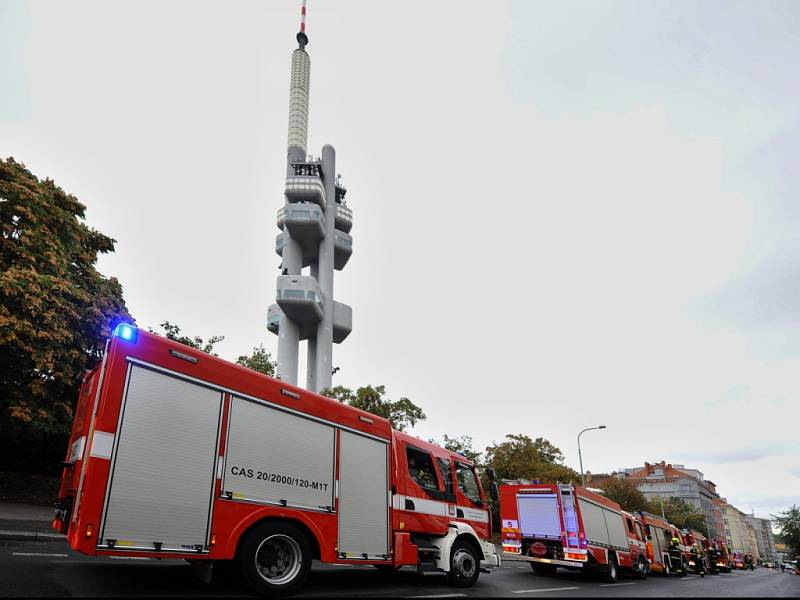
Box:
xmin=222 ymin=397 xmax=336 ymax=511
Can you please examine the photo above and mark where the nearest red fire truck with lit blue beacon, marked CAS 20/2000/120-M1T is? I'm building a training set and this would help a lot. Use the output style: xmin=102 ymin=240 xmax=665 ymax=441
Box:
xmin=53 ymin=324 xmax=500 ymax=595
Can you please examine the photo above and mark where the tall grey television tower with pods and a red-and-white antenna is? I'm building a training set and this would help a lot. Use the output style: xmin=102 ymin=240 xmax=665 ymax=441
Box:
xmin=267 ymin=0 xmax=353 ymax=392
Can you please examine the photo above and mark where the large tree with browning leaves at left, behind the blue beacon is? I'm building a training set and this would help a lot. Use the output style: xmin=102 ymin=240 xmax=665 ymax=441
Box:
xmin=0 ymin=158 xmax=133 ymax=468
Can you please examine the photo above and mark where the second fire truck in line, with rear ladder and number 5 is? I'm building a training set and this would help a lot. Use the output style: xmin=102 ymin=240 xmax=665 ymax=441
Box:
xmin=500 ymin=483 xmax=649 ymax=582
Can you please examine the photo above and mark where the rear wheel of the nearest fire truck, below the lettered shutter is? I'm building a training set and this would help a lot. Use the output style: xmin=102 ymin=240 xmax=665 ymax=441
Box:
xmin=236 ymin=522 xmax=311 ymax=596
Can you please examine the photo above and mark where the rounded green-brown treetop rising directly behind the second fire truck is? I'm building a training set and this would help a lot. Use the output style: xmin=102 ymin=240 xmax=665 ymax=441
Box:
xmin=486 ymin=434 xmax=580 ymax=482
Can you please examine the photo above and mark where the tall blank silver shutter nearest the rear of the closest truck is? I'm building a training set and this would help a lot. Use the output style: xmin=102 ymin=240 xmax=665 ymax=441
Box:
xmin=98 ymin=365 xmax=222 ymax=552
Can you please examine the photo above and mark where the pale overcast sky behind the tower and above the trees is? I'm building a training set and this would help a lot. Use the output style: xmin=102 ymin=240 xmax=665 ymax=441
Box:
xmin=0 ymin=0 xmax=800 ymax=516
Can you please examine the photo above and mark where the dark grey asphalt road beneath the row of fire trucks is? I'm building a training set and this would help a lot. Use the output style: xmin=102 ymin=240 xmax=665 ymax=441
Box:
xmin=0 ymin=541 xmax=800 ymax=598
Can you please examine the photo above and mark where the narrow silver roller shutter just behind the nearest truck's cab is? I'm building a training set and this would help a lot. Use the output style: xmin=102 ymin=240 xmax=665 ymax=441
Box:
xmin=339 ymin=431 xmax=389 ymax=559
